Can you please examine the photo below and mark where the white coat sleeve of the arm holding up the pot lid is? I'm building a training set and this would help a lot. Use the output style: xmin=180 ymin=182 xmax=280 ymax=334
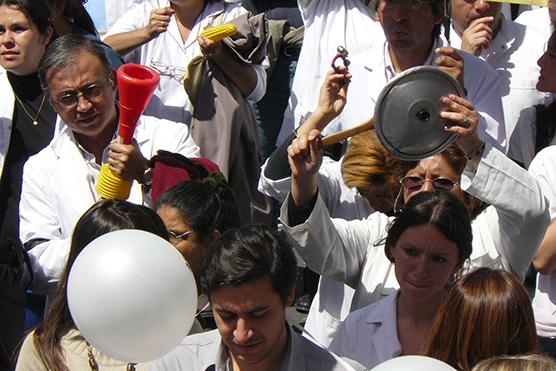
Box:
xmin=461 ymin=144 xmax=550 ymax=279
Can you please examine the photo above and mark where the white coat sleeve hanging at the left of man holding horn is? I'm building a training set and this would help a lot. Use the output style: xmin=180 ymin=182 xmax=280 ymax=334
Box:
xmin=19 ymin=158 xmax=70 ymax=294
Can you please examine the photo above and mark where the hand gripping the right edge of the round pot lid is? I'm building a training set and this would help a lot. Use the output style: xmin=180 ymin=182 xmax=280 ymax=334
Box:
xmin=440 ymin=94 xmax=483 ymax=155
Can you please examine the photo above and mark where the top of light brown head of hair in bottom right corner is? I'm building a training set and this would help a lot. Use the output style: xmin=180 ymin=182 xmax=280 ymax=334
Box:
xmin=472 ymin=353 xmax=556 ymax=371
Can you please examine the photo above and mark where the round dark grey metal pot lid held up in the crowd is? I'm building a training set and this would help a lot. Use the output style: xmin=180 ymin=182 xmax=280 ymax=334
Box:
xmin=374 ymin=66 xmax=465 ymax=160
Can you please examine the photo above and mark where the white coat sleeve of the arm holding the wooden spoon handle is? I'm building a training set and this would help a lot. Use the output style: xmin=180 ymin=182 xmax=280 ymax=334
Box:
xmin=280 ymin=194 xmax=388 ymax=288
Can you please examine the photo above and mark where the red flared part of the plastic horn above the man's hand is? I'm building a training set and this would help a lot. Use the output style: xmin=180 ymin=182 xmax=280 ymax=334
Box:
xmin=117 ymin=63 xmax=160 ymax=144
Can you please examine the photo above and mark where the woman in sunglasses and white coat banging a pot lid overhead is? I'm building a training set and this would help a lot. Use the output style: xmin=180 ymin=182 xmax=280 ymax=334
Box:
xmin=281 ymin=67 xmax=549 ymax=352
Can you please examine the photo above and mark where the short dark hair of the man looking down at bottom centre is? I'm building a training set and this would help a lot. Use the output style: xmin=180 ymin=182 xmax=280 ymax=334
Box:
xmin=200 ymin=226 xmax=297 ymax=303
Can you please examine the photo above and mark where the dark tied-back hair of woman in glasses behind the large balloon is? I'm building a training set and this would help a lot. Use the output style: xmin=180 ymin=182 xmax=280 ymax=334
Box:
xmin=155 ymin=172 xmax=240 ymax=242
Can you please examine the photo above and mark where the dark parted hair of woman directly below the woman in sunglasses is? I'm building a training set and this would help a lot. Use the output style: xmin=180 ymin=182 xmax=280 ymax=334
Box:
xmin=384 ymin=191 xmax=473 ymax=262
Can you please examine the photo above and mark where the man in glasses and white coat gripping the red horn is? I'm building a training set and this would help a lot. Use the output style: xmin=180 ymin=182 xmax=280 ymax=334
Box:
xmin=20 ymin=34 xmax=199 ymax=294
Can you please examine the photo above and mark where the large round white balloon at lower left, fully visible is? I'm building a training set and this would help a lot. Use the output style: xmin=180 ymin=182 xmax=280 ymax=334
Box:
xmin=67 ymin=230 xmax=197 ymax=363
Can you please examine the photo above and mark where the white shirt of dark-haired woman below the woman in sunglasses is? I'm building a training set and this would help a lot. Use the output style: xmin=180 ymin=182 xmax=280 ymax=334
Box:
xmin=330 ymin=291 xmax=403 ymax=369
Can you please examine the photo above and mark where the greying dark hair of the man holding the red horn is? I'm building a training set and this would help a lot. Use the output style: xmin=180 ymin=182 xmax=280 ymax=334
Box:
xmin=39 ymin=33 xmax=112 ymax=90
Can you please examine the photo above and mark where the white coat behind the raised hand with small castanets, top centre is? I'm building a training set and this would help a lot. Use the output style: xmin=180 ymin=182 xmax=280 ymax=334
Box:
xmin=277 ymin=0 xmax=385 ymax=145
